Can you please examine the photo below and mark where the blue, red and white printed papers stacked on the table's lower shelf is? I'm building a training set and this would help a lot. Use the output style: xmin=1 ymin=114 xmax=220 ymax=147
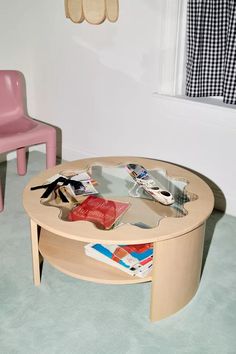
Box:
xmin=85 ymin=243 xmax=153 ymax=277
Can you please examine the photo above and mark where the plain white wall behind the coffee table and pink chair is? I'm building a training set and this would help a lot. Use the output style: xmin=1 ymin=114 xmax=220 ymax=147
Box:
xmin=0 ymin=0 xmax=236 ymax=215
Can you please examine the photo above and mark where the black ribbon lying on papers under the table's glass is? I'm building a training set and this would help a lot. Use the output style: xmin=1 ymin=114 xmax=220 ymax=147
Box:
xmin=30 ymin=177 xmax=85 ymax=202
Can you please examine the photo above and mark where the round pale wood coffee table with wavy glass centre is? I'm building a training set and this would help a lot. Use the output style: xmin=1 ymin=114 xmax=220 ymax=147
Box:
xmin=23 ymin=156 xmax=214 ymax=321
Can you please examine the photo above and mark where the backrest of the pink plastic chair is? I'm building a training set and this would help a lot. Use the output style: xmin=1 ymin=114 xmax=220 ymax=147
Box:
xmin=0 ymin=70 xmax=25 ymax=122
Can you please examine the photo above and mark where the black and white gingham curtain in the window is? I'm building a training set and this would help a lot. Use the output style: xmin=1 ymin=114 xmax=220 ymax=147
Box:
xmin=186 ymin=0 xmax=236 ymax=104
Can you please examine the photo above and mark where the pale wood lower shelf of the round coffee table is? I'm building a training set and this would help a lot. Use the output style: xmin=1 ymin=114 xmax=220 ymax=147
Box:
xmin=39 ymin=228 xmax=152 ymax=284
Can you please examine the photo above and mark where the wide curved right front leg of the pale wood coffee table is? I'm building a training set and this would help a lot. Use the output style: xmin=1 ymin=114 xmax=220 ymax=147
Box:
xmin=150 ymin=224 xmax=205 ymax=321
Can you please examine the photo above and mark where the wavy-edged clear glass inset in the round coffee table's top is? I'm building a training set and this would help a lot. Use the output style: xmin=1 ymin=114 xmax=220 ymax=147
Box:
xmin=41 ymin=164 xmax=198 ymax=229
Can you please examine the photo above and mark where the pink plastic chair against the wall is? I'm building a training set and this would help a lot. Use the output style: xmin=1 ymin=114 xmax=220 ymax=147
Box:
xmin=0 ymin=70 xmax=56 ymax=211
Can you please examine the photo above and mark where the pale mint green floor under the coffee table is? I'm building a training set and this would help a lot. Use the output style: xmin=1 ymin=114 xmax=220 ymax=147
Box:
xmin=0 ymin=152 xmax=236 ymax=354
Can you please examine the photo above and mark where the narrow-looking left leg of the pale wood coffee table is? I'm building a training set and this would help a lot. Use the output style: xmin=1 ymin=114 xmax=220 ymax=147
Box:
xmin=30 ymin=219 xmax=43 ymax=286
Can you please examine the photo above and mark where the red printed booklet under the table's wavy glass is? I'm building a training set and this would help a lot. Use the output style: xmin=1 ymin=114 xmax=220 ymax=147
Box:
xmin=68 ymin=195 xmax=129 ymax=230
